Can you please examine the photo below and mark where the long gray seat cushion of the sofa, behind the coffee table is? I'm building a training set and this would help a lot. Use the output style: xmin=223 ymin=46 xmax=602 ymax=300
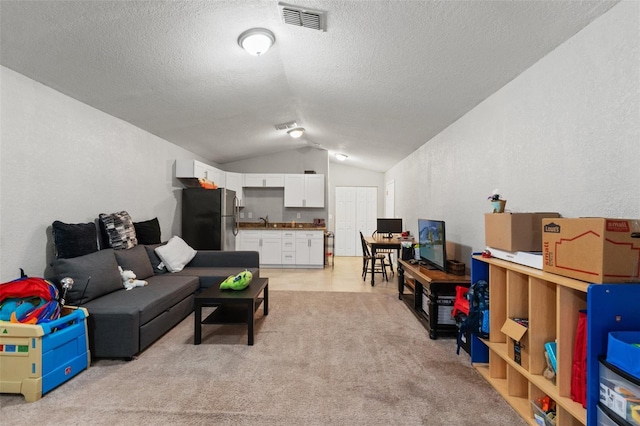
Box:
xmin=85 ymin=274 xmax=199 ymax=325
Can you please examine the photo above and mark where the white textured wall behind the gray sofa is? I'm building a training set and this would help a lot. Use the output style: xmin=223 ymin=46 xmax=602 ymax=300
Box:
xmin=0 ymin=67 xmax=211 ymax=282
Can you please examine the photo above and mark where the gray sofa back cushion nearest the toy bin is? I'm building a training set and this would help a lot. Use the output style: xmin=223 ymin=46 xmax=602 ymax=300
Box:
xmin=52 ymin=249 xmax=124 ymax=305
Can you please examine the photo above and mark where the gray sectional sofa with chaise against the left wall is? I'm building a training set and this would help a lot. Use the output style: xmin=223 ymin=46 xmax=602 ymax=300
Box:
xmin=50 ymin=244 xmax=260 ymax=359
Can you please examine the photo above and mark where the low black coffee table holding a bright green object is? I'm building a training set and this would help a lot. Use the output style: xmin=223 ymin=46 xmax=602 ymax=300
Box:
xmin=193 ymin=278 xmax=269 ymax=345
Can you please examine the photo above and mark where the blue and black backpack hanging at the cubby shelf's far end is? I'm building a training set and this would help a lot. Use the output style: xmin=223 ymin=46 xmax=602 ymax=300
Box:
xmin=456 ymin=280 xmax=489 ymax=354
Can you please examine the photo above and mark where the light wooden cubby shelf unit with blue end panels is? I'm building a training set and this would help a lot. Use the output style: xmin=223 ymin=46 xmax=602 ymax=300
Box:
xmin=471 ymin=254 xmax=640 ymax=426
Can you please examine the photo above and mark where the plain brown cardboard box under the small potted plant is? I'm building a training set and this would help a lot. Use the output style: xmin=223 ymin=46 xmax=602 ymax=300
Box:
xmin=484 ymin=212 xmax=560 ymax=252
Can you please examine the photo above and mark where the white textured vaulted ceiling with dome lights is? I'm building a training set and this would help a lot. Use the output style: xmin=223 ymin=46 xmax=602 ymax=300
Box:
xmin=0 ymin=0 xmax=617 ymax=172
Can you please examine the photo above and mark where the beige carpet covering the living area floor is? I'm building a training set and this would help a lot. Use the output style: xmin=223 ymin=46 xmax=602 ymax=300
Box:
xmin=0 ymin=291 xmax=526 ymax=426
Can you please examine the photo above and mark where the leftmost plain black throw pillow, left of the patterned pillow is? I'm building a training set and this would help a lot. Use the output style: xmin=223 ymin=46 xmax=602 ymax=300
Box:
xmin=51 ymin=220 xmax=98 ymax=259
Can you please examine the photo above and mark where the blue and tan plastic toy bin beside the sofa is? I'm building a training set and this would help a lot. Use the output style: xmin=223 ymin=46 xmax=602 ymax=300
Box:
xmin=0 ymin=307 xmax=91 ymax=402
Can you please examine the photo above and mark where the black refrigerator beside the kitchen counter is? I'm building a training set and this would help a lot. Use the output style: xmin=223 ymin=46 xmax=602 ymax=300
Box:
xmin=182 ymin=188 xmax=239 ymax=251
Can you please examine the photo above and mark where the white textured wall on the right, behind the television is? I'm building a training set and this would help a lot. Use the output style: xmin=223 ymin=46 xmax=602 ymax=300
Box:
xmin=385 ymin=1 xmax=640 ymax=263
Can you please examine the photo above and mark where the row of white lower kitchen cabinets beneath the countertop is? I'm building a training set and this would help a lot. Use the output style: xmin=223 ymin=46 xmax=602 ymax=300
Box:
xmin=238 ymin=229 xmax=324 ymax=268
